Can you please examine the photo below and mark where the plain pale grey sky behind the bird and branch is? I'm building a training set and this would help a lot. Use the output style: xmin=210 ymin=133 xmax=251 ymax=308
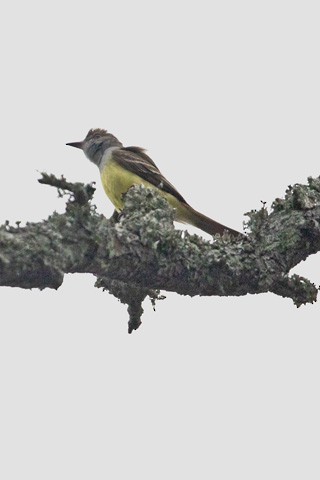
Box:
xmin=0 ymin=0 xmax=320 ymax=480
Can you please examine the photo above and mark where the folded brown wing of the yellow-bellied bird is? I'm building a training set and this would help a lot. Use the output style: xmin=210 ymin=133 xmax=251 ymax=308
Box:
xmin=112 ymin=147 xmax=187 ymax=204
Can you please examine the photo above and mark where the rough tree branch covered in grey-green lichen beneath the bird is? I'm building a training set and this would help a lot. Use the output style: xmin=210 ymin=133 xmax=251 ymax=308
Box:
xmin=0 ymin=174 xmax=320 ymax=333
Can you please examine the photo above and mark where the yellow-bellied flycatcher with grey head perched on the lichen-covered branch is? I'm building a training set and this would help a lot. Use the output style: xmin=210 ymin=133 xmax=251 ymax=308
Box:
xmin=67 ymin=128 xmax=241 ymax=235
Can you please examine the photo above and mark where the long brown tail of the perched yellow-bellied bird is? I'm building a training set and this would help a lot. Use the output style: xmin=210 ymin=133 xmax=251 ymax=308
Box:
xmin=177 ymin=204 xmax=243 ymax=236
